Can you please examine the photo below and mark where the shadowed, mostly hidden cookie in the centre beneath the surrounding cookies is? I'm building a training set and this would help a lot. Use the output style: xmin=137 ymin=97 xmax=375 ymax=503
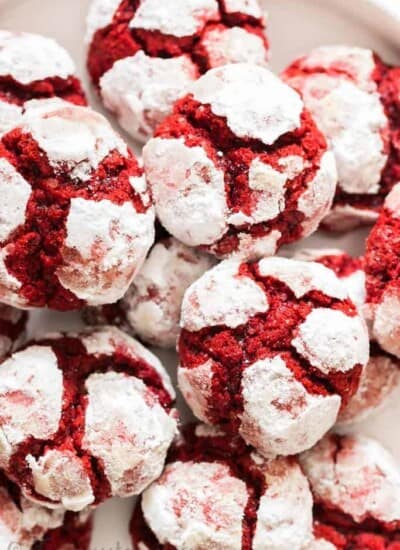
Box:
xmin=84 ymin=237 xmax=213 ymax=348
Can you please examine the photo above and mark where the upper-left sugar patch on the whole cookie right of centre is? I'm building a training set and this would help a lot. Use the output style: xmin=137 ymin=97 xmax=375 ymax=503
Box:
xmin=181 ymin=260 xmax=269 ymax=331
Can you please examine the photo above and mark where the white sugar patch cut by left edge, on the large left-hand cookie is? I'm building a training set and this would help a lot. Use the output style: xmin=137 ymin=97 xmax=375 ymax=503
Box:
xmin=0 ymin=158 xmax=32 ymax=245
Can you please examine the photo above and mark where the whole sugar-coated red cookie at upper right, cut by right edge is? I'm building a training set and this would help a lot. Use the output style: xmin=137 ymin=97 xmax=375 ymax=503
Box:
xmin=283 ymin=46 xmax=400 ymax=231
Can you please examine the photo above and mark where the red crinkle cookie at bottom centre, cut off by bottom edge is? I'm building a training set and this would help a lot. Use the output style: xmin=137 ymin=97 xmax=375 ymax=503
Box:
xmin=131 ymin=425 xmax=312 ymax=550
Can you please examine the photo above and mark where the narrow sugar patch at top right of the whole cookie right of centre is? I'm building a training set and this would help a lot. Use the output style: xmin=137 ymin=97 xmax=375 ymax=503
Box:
xmin=258 ymin=257 xmax=347 ymax=300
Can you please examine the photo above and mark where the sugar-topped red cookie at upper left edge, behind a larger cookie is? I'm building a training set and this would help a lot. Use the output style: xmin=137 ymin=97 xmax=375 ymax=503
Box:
xmin=0 ymin=31 xmax=86 ymax=136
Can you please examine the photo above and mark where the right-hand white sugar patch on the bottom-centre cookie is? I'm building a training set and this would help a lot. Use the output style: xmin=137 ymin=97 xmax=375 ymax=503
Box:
xmin=252 ymin=458 xmax=313 ymax=550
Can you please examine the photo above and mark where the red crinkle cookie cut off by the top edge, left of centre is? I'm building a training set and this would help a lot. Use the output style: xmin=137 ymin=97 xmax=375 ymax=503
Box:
xmin=86 ymin=0 xmax=268 ymax=141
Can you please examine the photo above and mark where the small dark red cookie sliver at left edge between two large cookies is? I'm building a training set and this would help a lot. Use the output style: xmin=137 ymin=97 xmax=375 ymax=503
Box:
xmin=0 ymin=304 xmax=28 ymax=360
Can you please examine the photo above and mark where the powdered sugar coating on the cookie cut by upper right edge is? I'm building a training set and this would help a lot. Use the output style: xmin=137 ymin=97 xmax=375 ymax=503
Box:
xmin=283 ymin=46 xmax=389 ymax=230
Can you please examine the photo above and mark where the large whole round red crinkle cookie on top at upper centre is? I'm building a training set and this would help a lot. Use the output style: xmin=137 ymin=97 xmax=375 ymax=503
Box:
xmin=143 ymin=63 xmax=336 ymax=258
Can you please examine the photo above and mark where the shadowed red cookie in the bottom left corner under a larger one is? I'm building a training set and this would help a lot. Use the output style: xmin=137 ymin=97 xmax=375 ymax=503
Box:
xmin=0 ymin=472 xmax=92 ymax=550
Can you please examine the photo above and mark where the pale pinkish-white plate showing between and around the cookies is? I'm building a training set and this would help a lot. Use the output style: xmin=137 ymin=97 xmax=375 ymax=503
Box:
xmin=0 ymin=0 xmax=400 ymax=550
